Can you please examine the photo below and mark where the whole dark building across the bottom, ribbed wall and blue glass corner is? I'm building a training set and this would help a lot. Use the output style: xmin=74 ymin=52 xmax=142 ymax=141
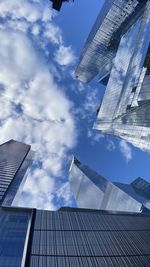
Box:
xmin=0 ymin=208 xmax=150 ymax=267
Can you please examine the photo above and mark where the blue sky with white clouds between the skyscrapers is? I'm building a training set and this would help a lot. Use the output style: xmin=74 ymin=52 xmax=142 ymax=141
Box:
xmin=0 ymin=0 xmax=150 ymax=210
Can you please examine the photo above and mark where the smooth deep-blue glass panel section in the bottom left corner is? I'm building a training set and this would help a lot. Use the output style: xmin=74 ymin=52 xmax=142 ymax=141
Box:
xmin=0 ymin=208 xmax=31 ymax=267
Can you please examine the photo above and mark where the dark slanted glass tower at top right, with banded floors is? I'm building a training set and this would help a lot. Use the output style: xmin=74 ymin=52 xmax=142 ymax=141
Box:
xmin=76 ymin=0 xmax=147 ymax=82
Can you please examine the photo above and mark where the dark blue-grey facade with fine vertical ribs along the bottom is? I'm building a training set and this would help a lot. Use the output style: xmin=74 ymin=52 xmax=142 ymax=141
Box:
xmin=29 ymin=208 xmax=150 ymax=267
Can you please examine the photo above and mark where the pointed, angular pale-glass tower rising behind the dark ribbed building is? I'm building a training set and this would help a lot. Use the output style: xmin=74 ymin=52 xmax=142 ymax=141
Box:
xmin=69 ymin=158 xmax=150 ymax=213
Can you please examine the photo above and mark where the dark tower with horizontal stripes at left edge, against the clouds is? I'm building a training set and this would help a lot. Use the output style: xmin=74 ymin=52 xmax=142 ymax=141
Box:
xmin=0 ymin=140 xmax=33 ymax=206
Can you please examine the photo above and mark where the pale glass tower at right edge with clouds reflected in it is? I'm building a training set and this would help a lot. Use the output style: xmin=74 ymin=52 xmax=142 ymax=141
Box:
xmin=94 ymin=1 xmax=150 ymax=151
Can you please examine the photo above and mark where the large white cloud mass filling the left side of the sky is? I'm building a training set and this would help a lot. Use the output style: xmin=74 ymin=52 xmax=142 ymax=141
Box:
xmin=0 ymin=0 xmax=77 ymax=209
